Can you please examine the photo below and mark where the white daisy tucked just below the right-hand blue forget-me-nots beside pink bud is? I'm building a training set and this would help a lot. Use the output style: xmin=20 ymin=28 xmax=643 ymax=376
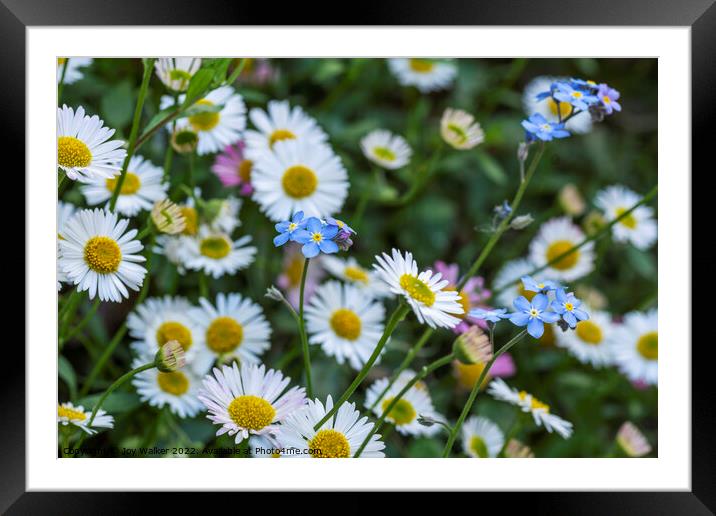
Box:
xmin=554 ymin=311 xmax=614 ymax=367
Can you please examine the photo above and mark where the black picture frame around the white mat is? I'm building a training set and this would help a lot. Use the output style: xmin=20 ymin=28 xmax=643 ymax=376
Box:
xmin=0 ymin=0 xmax=716 ymax=510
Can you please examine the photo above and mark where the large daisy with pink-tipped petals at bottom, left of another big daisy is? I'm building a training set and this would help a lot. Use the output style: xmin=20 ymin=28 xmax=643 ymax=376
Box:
xmin=199 ymin=362 xmax=306 ymax=444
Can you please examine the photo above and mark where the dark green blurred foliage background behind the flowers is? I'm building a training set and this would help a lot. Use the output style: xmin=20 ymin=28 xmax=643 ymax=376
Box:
xmin=59 ymin=59 xmax=657 ymax=457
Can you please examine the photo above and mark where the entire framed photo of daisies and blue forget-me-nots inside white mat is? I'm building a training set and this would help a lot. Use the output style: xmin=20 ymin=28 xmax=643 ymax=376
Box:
xmin=56 ymin=57 xmax=658 ymax=458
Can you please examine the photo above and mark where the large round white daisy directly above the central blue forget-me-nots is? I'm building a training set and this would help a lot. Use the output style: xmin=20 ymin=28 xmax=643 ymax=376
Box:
xmin=251 ymin=140 xmax=348 ymax=222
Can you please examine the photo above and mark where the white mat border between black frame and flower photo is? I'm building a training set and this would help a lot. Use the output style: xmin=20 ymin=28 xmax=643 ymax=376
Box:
xmin=26 ymin=27 xmax=691 ymax=491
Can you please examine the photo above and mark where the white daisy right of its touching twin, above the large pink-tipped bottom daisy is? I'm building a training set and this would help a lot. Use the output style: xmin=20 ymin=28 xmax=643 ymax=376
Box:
xmin=191 ymin=293 xmax=271 ymax=364
